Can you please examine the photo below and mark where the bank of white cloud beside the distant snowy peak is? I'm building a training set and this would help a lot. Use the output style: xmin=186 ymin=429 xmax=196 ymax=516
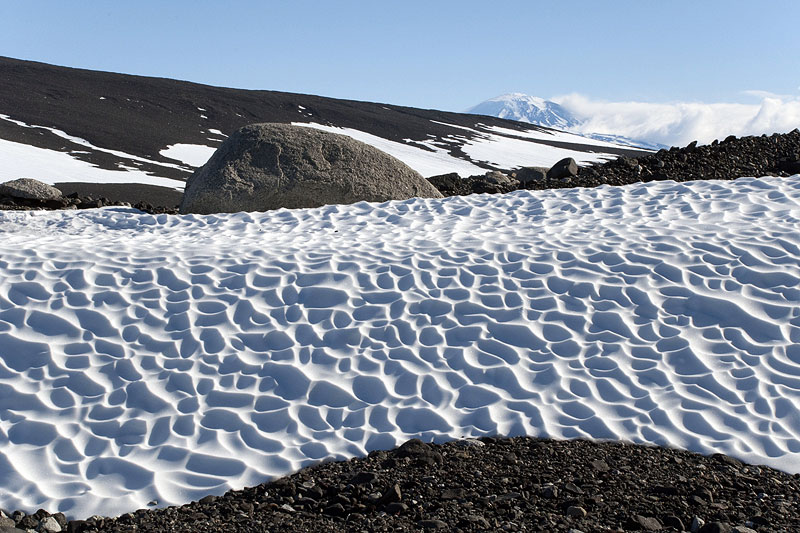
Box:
xmin=552 ymin=91 xmax=800 ymax=146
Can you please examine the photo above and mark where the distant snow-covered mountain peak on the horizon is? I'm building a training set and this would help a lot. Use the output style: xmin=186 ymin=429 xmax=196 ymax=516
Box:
xmin=467 ymin=93 xmax=668 ymax=150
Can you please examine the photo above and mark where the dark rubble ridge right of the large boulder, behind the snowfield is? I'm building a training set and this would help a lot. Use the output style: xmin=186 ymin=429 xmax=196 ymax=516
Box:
xmin=428 ymin=129 xmax=800 ymax=196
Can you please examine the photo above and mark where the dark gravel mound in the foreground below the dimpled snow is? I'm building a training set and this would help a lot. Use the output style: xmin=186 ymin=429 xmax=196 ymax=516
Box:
xmin=0 ymin=437 xmax=800 ymax=533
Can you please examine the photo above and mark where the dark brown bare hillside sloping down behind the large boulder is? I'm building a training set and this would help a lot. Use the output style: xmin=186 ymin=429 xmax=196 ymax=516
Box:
xmin=0 ymin=57 xmax=642 ymax=184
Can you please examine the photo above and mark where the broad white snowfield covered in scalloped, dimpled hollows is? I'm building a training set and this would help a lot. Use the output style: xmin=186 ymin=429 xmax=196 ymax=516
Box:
xmin=0 ymin=176 xmax=800 ymax=517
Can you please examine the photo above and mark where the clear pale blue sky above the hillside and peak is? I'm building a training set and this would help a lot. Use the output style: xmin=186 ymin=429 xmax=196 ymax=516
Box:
xmin=0 ymin=0 xmax=800 ymax=111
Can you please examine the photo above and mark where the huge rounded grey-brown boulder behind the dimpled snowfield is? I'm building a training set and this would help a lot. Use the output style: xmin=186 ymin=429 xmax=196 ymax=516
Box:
xmin=180 ymin=124 xmax=442 ymax=214
